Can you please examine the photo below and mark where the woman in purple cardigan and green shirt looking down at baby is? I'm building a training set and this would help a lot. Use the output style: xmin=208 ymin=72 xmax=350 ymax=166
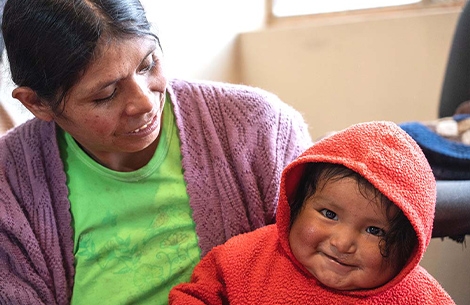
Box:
xmin=0 ymin=0 xmax=311 ymax=304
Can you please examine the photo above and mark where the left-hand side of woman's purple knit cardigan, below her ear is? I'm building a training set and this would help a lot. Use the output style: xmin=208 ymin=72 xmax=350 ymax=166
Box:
xmin=0 ymin=119 xmax=74 ymax=305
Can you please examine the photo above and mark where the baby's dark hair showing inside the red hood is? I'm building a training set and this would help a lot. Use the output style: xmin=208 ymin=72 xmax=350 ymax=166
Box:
xmin=289 ymin=163 xmax=418 ymax=270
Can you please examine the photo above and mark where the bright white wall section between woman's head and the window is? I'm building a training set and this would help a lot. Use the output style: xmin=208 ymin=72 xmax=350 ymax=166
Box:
xmin=142 ymin=0 xmax=265 ymax=82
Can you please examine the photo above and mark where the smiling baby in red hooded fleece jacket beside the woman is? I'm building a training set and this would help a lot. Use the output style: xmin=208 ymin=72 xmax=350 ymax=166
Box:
xmin=169 ymin=122 xmax=455 ymax=305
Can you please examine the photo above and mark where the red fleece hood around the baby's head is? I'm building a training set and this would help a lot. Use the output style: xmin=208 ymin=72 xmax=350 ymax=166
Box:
xmin=276 ymin=121 xmax=436 ymax=295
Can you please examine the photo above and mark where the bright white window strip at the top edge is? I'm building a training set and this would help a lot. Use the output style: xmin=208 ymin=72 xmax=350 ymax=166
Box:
xmin=273 ymin=0 xmax=421 ymax=17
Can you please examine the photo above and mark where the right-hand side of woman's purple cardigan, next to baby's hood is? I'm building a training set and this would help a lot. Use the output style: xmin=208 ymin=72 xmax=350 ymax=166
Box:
xmin=168 ymin=80 xmax=311 ymax=256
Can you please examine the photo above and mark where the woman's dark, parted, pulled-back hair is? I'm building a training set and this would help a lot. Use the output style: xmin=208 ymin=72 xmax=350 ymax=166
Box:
xmin=2 ymin=0 xmax=159 ymax=113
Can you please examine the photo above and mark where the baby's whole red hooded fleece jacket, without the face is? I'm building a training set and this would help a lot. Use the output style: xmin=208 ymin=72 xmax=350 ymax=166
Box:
xmin=170 ymin=122 xmax=454 ymax=305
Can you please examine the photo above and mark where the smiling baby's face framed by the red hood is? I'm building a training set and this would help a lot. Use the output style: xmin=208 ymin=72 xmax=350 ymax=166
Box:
xmin=289 ymin=178 xmax=398 ymax=290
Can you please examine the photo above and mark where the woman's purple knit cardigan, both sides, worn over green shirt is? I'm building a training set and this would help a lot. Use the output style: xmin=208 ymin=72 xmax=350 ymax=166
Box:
xmin=0 ymin=80 xmax=311 ymax=305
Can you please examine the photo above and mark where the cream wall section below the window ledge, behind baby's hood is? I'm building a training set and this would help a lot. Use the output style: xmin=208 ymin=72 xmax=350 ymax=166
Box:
xmin=241 ymin=12 xmax=458 ymax=138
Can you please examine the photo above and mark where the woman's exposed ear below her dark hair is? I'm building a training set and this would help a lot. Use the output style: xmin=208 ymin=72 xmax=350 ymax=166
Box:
xmin=12 ymin=87 xmax=54 ymax=122
